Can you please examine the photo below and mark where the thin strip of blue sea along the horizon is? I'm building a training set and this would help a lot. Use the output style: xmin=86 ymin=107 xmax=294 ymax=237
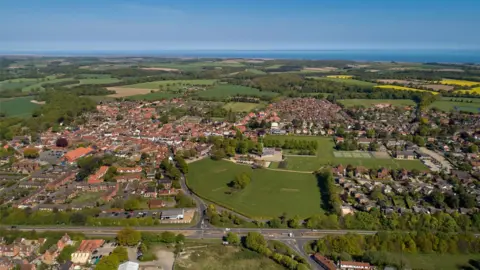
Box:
xmin=0 ymin=49 xmax=480 ymax=64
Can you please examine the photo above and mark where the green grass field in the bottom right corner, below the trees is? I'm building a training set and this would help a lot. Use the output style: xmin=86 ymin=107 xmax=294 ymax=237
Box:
xmin=397 ymin=253 xmax=480 ymax=270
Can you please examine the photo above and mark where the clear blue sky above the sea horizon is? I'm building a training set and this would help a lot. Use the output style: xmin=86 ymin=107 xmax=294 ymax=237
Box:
xmin=0 ymin=0 xmax=480 ymax=51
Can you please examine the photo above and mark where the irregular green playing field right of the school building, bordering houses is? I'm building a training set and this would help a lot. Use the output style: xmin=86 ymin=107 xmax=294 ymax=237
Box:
xmin=267 ymin=136 xmax=427 ymax=171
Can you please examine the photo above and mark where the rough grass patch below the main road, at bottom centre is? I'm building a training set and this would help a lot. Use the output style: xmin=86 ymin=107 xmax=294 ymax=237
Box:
xmin=174 ymin=243 xmax=285 ymax=270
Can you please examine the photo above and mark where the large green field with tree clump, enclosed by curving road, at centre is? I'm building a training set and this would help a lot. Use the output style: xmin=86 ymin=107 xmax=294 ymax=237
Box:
xmin=187 ymin=159 xmax=323 ymax=219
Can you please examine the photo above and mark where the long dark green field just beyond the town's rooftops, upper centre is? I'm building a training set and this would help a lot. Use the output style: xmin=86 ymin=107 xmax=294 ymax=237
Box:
xmin=198 ymin=84 xmax=278 ymax=98
